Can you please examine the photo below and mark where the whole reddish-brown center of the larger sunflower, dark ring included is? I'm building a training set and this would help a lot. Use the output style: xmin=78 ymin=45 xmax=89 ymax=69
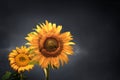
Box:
xmin=40 ymin=37 xmax=63 ymax=57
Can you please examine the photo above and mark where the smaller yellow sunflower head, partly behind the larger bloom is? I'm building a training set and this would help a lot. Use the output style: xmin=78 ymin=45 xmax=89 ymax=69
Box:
xmin=8 ymin=46 xmax=34 ymax=73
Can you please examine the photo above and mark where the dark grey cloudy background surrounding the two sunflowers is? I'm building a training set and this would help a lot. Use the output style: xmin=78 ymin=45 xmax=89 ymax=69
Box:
xmin=0 ymin=0 xmax=120 ymax=80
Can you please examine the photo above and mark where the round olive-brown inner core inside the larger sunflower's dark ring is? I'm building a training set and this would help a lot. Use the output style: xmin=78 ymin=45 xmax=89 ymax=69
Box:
xmin=44 ymin=38 xmax=58 ymax=52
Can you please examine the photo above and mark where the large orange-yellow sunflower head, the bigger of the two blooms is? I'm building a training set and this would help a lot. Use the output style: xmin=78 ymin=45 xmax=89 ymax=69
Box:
xmin=26 ymin=20 xmax=75 ymax=68
